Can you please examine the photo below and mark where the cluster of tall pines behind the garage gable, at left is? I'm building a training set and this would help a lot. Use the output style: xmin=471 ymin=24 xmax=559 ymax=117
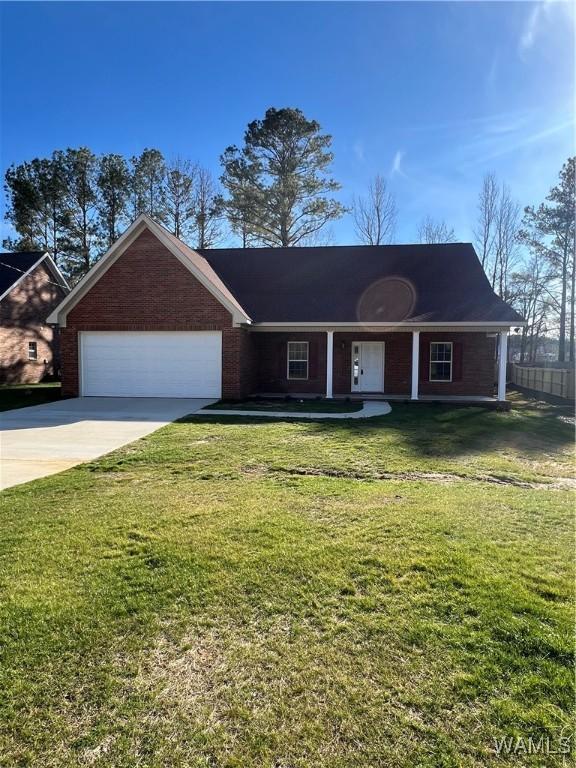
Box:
xmin=4 ymin=147 xmax=220 ymax=280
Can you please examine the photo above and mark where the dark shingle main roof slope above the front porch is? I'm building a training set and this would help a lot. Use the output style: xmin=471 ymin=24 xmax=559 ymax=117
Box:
xmin=200 ymin=243 xmax=521 ymax=323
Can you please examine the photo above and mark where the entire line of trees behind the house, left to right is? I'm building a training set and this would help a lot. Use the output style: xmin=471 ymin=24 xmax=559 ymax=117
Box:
xmin=4 ymin=108 xmax=576 ymax=361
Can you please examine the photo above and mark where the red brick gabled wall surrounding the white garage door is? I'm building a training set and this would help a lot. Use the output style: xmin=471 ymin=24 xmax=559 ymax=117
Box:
xmin=61 ymin=231 xmax=247 ymax=398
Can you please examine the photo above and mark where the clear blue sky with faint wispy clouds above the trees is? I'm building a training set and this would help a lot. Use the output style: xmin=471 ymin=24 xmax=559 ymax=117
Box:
xmin=0 ymin=2 xmax=575 ymax=243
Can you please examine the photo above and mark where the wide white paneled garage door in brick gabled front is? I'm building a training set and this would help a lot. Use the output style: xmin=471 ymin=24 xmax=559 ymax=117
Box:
xmin=80 ymin=331 xmax=222 ymax=397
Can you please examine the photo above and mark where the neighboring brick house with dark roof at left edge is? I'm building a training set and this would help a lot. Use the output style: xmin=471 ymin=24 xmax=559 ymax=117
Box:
xmin=0 ymin=251 xmax=70 ymax=384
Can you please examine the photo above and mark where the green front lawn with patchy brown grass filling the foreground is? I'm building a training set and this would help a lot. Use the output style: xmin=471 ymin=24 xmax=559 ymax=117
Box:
xmin=0 ymin=392 xmax=574 ymax=768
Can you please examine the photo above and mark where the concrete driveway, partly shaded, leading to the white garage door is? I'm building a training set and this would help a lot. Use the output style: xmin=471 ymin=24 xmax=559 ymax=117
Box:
xmin=0 ymin=397 xmax=215 ymax=489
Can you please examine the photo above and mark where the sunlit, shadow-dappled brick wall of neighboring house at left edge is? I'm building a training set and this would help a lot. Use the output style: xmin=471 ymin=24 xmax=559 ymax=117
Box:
xmin=0 ymin=264 xmax=65 ymax=384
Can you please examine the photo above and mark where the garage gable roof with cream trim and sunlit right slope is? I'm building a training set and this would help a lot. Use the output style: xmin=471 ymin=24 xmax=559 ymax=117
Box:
xmin=47 ymin=214 xmax=251 ymax=327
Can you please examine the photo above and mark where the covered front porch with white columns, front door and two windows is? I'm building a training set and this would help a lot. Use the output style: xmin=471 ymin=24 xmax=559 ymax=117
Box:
xmin=245 ymin=326 xmax=509 ymax=405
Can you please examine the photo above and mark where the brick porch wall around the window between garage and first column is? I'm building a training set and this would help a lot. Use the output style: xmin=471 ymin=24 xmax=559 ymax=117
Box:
xmin=251 ymin=332 xmax=326 ymax=395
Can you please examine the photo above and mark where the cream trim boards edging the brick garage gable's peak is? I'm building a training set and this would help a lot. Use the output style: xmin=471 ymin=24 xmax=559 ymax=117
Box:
xmin=47 ymin=214 xmax=252 ymax=328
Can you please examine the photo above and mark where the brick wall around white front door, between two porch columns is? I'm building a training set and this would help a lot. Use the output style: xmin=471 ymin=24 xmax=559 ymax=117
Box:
xmin=334 ymin=332 xmax=412 ymax=396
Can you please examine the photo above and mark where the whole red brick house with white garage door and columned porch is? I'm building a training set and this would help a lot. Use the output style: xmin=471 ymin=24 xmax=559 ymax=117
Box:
xmin=49 ymin=216 xmax=522 ymax=400
